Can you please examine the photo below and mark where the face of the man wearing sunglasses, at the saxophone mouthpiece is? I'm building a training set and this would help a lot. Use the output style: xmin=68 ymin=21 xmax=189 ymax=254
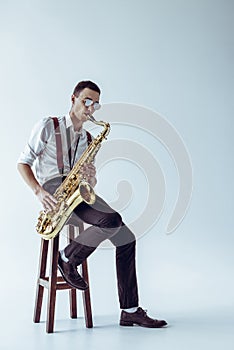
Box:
xmin=72 ymin=88 xmax=100 ymax=122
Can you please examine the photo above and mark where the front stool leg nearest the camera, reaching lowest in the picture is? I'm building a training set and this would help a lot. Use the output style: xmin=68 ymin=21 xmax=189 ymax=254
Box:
xmin=46 ymin=235 xmax=59 ymax=333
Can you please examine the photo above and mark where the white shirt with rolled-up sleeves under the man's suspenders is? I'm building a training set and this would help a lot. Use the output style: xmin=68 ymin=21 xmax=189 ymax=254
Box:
xmin=18 ymin=114 xmax=91 ymax=185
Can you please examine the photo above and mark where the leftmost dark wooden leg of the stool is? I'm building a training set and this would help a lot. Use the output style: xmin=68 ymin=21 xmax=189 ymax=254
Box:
xmin=33 ymin=238 xmax=49 ymax=323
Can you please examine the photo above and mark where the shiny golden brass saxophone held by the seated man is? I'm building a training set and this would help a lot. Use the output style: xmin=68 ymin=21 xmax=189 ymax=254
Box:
xmin=36 ymin=115 xmax=110 ymax=240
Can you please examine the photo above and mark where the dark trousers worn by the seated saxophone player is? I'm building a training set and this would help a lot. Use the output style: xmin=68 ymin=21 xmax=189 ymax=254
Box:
xmin=64 ymin=196 xmax=138 ymax=309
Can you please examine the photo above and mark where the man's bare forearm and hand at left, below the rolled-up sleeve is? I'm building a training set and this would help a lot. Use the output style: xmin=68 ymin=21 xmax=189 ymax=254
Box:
xmin=17 ymin=163 xmax=56 ymax=210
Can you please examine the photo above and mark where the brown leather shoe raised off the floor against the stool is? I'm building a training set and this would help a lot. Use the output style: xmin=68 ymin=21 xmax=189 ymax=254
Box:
xmin=58 ymin=253 xmax=89 ymax=290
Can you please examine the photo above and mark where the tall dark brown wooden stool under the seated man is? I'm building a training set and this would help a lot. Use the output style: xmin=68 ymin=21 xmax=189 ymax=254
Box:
xmin=33 ymin=222 xmax=93 ymax=333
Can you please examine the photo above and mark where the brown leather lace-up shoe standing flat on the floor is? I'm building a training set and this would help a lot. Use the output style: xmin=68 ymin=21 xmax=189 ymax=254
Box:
xmin=119 ymin=307 xmax=167 ymax=328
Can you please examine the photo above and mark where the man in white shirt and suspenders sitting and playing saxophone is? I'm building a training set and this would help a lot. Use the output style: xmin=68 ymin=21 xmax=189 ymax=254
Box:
xmin=18 ymin=81 xmax=167 ymax=328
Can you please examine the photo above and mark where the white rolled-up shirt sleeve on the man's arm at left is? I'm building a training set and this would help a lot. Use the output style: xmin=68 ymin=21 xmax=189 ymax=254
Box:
xmin=18 ymin=117 xmax=50 ymax=166
